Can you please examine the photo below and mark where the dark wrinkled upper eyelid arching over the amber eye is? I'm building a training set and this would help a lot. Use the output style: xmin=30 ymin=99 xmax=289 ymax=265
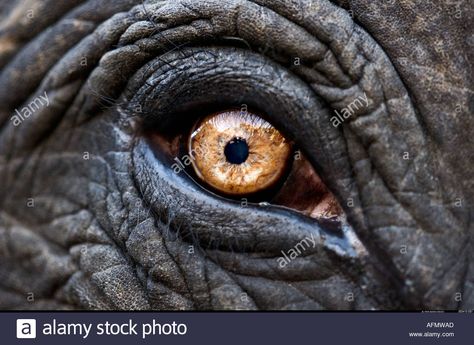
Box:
xmin=128 ymin=47 xmax=345 ymax=218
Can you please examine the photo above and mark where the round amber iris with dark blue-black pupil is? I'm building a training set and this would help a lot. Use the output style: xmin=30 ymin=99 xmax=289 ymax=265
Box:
xmin=189 ymin=110 xmax=292 ymax=195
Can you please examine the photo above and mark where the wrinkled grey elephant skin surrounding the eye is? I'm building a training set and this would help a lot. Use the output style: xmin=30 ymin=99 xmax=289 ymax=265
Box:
xmin=0 ymin=0 xmax=474 ymax=310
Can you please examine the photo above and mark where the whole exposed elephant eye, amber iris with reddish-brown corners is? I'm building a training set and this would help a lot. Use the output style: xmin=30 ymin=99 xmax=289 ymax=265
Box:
xmin=147 ymin=108 xmax=344 ymax=220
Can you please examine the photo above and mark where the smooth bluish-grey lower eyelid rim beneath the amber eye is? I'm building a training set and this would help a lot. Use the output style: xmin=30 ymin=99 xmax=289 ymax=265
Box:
xmin=132 ymin=136 xmax=351 ymax=254
